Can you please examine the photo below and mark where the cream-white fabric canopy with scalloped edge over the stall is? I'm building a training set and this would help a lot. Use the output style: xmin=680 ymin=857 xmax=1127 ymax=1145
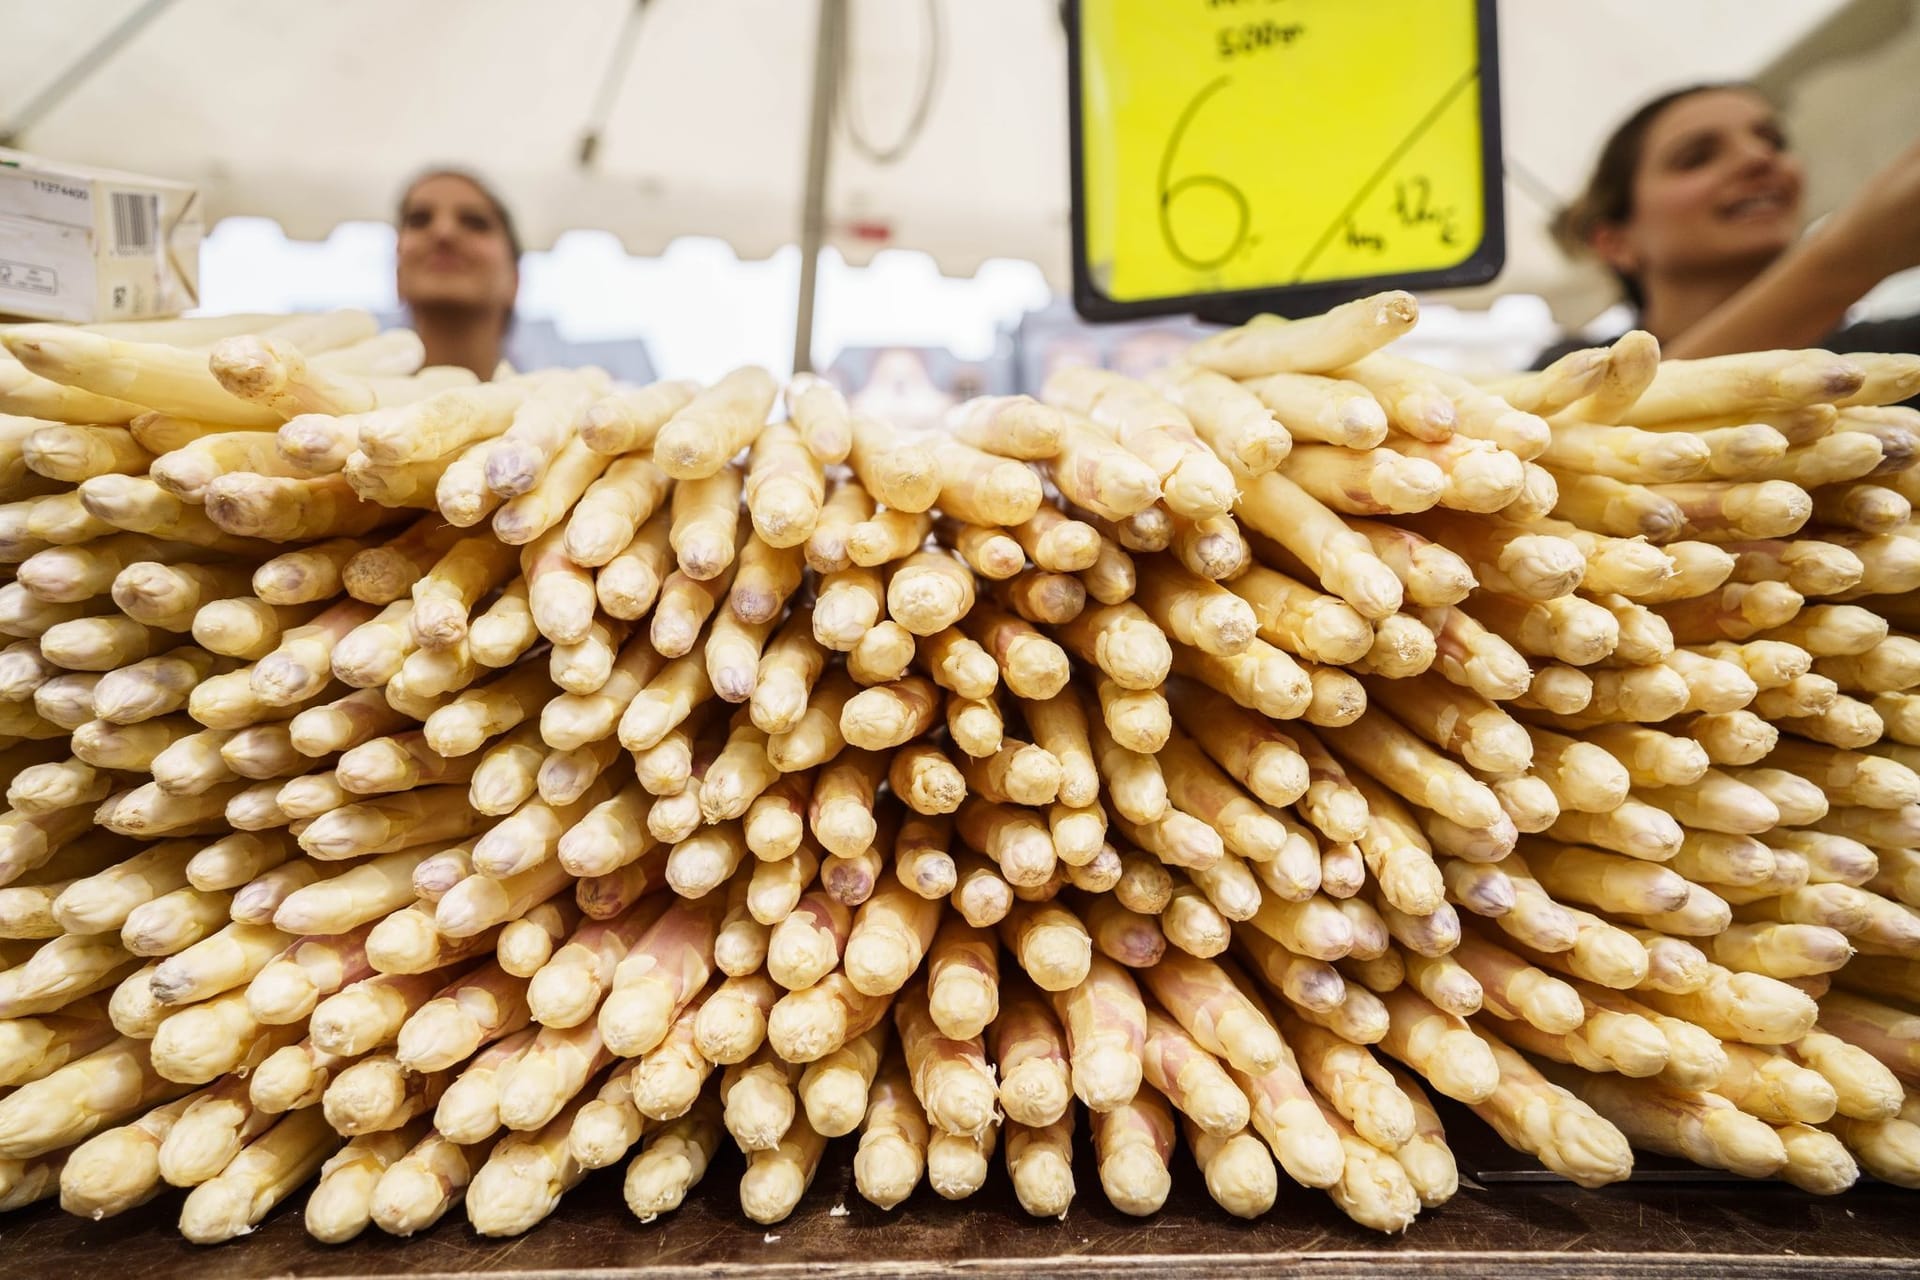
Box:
xmin=0 ymin=0 xmax=1920 ymax=322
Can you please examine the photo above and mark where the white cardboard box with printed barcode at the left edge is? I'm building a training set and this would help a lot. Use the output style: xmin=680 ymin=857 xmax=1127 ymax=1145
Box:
xmin=0 ymin=148 xmax=205 ymax=324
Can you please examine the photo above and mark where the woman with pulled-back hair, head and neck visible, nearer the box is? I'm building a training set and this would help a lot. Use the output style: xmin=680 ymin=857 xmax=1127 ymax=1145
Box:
xmin=396 ymin=169 xmax=520 ymax=380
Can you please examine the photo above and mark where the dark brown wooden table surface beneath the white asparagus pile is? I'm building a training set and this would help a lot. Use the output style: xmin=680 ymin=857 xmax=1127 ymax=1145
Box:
xmin=11 ymin=1115 xmax=1920 ymax=1280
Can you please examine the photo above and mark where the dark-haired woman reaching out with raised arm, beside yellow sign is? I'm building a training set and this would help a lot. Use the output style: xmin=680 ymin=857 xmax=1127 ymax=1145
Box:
xmin=1542 ymin=84 xmax=1920 ymax=363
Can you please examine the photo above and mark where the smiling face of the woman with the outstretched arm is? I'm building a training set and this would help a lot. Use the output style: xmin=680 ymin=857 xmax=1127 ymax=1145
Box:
xmin=1596 ymin=88 xmax=1801 ymax=276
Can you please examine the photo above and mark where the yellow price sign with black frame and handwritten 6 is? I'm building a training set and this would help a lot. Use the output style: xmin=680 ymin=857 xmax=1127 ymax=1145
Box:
xmin=1069 ymin=0 xmax=1505 ymax=319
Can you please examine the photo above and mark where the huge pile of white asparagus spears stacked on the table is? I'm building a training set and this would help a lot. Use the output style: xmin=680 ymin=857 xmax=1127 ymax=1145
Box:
xmin=0 ymin=294 xmax=1920 ymax=1242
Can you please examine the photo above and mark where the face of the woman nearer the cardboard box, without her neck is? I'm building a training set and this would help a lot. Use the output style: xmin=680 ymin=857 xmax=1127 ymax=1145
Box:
xmin=397 ymin=175 xmax=520 ymax=313
